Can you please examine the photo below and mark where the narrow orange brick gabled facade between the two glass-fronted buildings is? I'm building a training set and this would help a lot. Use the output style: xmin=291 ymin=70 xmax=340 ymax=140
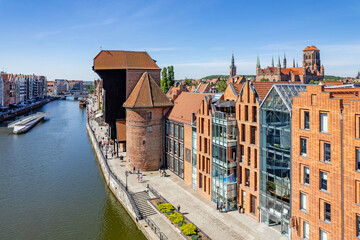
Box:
xmin=236 ymin=81 xmax=260 ymax=221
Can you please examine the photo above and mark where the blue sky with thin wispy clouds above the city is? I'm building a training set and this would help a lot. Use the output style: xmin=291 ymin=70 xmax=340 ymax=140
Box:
xmin=0 ymin=0 xmax=360 ymax=81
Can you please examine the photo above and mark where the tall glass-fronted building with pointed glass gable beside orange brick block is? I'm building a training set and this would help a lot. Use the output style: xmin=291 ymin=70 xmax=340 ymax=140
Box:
xmin=260 ymin=84 xmax=306 ymax=235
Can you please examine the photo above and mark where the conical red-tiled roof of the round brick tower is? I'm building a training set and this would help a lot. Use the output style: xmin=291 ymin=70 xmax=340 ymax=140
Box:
xmin=123 ymin=72 xmax=173 ymax=108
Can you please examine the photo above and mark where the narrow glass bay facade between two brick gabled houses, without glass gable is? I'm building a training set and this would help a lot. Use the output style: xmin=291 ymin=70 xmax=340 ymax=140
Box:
xmin=211 ymin=100 xmax=237 ymax=210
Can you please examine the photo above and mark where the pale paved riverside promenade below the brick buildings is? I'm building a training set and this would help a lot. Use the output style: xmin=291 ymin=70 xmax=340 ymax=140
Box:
xmin=88 ymin=96 xmax=287 ymax=240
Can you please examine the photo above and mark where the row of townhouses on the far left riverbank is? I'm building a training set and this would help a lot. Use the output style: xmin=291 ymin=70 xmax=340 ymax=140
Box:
xmin=0 ymin=72 xmax=47 ymax=107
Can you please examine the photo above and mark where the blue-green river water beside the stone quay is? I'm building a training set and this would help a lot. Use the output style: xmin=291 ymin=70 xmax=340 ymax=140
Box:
xmin=0 ymin=100 xmax=146 ymax=239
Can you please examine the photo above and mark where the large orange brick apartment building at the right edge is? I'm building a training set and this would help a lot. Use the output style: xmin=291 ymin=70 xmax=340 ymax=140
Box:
xmin=292 ymin=86 xmax=360 ymax=239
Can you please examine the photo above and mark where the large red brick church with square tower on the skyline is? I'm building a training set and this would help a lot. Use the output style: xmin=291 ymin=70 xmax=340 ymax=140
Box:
xmin=256 ymin=46 xmax=324 ymax=83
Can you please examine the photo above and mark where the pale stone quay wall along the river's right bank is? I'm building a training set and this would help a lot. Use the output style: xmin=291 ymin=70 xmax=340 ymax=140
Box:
xmin=86 ymin=121 xmax=151 ymax=239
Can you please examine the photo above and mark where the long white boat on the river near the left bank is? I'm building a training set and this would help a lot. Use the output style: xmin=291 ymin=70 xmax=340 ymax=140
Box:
xmin=8 ymin=112 xmax=50 ymax=134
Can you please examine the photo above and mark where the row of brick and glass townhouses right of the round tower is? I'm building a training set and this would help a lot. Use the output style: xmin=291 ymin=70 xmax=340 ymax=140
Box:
xmin=165 ymin=80 xmax=360 ymax=239
